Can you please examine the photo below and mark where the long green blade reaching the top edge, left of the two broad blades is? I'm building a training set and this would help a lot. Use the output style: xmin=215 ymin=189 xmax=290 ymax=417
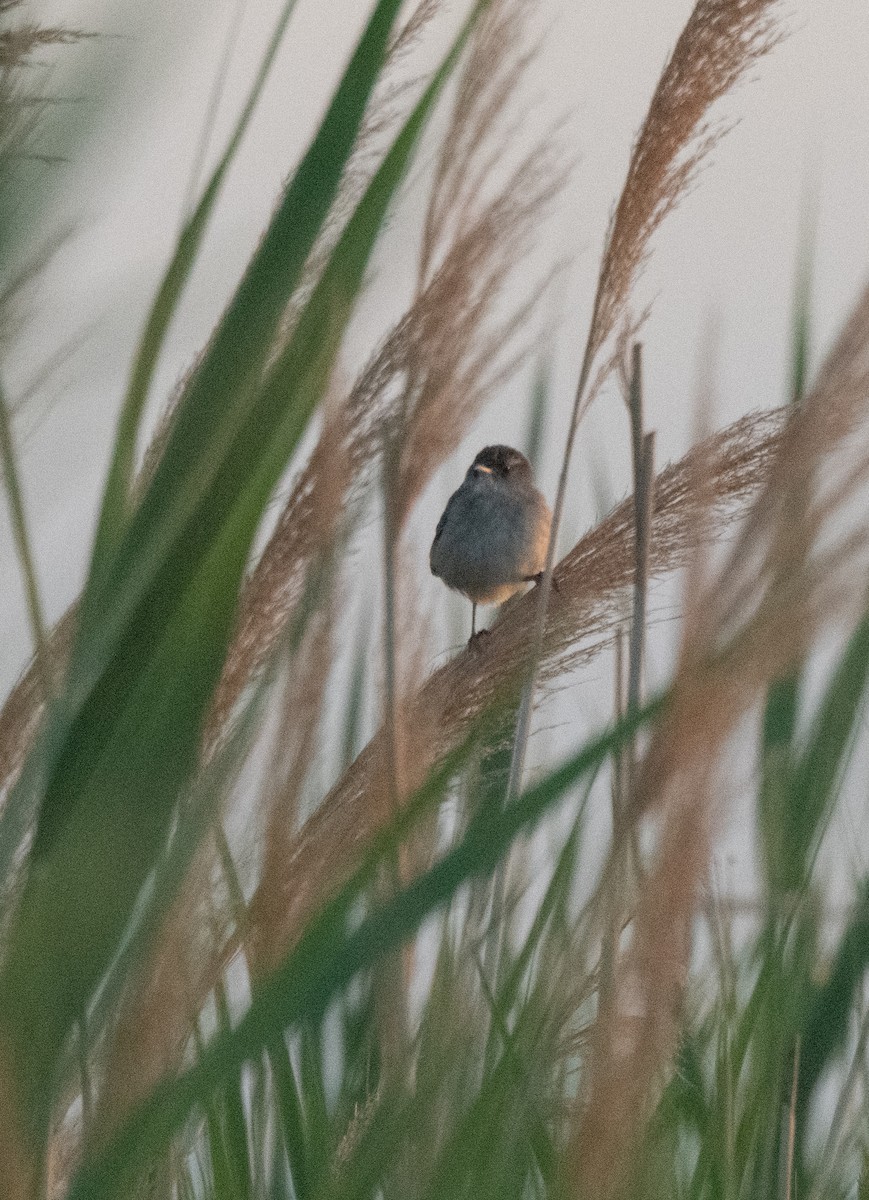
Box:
xmin=0 ymin=0 xmax=408 ymax=882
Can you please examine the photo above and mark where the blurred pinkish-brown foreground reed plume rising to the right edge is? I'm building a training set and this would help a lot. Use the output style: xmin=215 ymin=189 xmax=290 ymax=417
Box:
xmin=568 ymin=274 xmax=869 ymax=1198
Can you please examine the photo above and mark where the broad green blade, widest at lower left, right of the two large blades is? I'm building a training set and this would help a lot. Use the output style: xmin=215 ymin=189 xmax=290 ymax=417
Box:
xmin=0 ymin=10 xmax=479 ymax=1128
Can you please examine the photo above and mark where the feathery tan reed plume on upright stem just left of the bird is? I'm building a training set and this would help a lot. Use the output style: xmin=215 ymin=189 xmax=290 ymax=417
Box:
xmin=378 ymin=0 xmax=568 ymax=954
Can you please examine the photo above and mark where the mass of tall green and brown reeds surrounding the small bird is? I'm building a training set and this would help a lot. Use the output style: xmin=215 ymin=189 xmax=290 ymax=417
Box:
xmin=0 ymin=0 xmax=869 ymax=1200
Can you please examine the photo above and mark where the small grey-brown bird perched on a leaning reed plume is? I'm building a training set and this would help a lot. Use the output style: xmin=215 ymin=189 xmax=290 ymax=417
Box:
xmin=428 ymin=446 xmax=552 ymax=641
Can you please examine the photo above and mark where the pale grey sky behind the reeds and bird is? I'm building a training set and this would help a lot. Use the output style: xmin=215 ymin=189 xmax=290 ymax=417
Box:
xmin=0 ymin=0 xmax=869 ymax=902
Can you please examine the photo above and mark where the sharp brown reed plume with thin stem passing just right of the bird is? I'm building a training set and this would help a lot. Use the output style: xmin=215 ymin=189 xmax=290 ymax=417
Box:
xmin=509 ymin=0 xmax=784 ymax=796
